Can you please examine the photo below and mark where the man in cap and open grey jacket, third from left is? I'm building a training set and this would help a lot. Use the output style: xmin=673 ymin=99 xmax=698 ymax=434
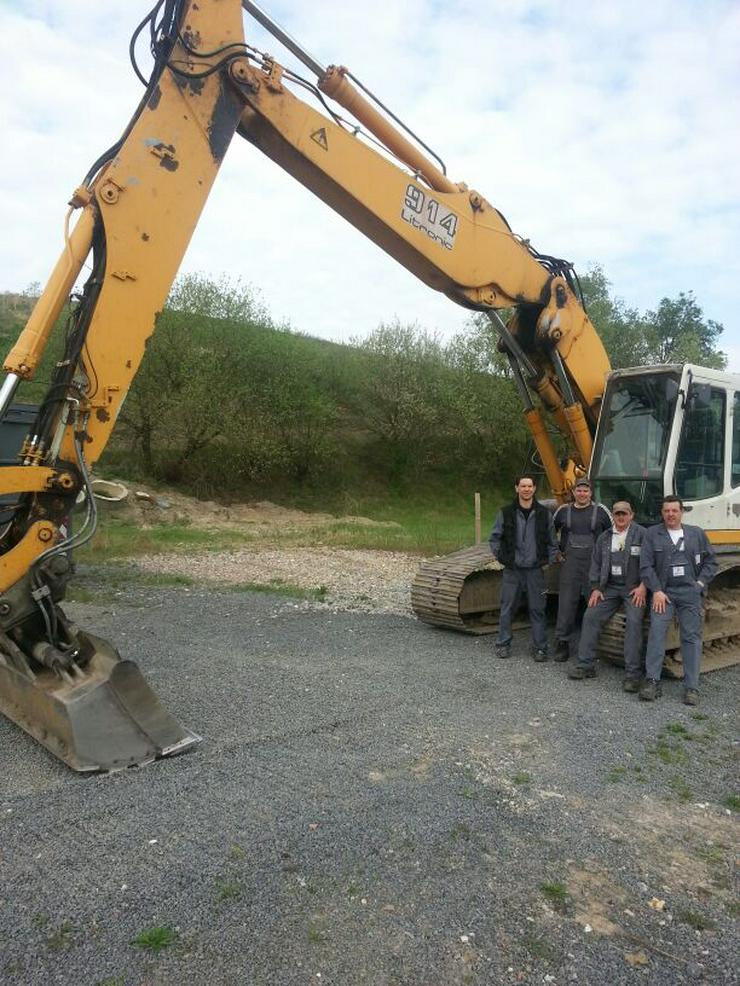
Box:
xmin=568 ymin=500 xmax=647 ymax=692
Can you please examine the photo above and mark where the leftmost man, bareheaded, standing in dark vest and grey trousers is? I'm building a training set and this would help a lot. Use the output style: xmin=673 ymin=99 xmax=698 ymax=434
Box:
xmin=488 ymin=475 xmax=558 ymax=661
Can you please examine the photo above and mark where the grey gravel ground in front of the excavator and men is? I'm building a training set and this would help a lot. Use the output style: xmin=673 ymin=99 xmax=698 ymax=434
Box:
xmin=0 ymin=559 xmax=740 ymax=986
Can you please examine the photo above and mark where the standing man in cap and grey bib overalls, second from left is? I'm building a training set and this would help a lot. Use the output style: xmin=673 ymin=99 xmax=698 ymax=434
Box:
xmin=553 ymin=476 xmax=612 ymax=661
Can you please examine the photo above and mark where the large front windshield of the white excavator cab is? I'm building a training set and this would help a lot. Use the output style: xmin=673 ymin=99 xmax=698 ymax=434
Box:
xmin=592 ymin=372 xmax=679 ymax=524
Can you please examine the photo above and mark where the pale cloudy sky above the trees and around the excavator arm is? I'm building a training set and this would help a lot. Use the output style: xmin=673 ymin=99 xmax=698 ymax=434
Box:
xmin=0 ymin=0 xmax=740 ymax=372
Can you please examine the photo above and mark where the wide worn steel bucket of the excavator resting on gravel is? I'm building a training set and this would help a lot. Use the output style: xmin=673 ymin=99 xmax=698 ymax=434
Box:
xmin=0 ymin=633 xmax=200 ymax=772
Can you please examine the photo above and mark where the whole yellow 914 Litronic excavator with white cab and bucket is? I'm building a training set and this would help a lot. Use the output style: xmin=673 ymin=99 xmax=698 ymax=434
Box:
xmin=0 ymin=0 xmax=740 ymax=771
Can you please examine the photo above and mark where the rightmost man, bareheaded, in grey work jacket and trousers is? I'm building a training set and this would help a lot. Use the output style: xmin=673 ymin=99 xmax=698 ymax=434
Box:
xmin=640 ymin=496 xmax=718 ymax=705
